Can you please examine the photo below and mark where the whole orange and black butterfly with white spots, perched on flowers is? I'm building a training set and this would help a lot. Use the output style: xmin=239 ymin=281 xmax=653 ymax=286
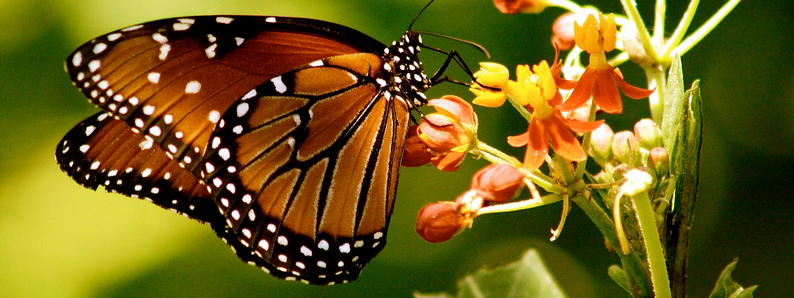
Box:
xmin=56 ymin=12 xmax=470 ymax=285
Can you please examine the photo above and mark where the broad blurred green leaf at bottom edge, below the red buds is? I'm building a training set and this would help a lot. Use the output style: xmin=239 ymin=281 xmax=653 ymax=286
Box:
xmin=414 ymin=248 xmax=567 ymax=298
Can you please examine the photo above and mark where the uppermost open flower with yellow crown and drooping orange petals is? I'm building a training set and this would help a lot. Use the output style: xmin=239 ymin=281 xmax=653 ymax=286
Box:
xmin=559 ymin=13 xmax=653 ymax=114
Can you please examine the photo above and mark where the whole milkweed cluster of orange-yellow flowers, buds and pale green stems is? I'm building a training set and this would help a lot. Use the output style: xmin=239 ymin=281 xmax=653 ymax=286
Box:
xmin=403 ymin=0 xmax=738 ymax=297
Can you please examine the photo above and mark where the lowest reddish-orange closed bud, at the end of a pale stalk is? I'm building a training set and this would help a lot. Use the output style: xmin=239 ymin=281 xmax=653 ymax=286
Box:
xmin=416 ymin=202 xmax=471 ymax=243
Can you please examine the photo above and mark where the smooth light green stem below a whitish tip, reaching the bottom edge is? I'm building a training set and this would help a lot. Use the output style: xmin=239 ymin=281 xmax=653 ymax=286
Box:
xmin=630 ymin=192 xmax=672 ymax=298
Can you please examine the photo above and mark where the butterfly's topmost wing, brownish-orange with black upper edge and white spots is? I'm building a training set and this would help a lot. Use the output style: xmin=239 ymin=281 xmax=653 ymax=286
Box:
xmin=65 ymin=16 xmax=384 ymax=173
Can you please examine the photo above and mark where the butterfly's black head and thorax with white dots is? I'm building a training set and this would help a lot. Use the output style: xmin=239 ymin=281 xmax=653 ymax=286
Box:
xmin=383 ymin=31 xmax=431 ymax=107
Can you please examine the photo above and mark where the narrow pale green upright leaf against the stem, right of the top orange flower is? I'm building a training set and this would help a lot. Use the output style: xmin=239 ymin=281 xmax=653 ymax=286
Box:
xmin=662 ymin=55 xmax=687 ymax=164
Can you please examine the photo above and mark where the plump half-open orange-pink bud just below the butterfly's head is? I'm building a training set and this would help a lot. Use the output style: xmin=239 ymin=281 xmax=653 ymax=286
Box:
xmin=417 ymin=95 xmax=477 ymax=172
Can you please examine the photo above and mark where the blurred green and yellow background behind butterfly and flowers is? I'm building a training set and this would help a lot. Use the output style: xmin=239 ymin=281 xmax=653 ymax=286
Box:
xmin=0 ymin=0 xmax=794 ymax=297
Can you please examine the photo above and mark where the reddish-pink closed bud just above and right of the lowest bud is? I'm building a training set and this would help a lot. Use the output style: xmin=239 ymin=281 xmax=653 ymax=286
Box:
xmin=471 ymin=164 xmax=524 ymax=203
